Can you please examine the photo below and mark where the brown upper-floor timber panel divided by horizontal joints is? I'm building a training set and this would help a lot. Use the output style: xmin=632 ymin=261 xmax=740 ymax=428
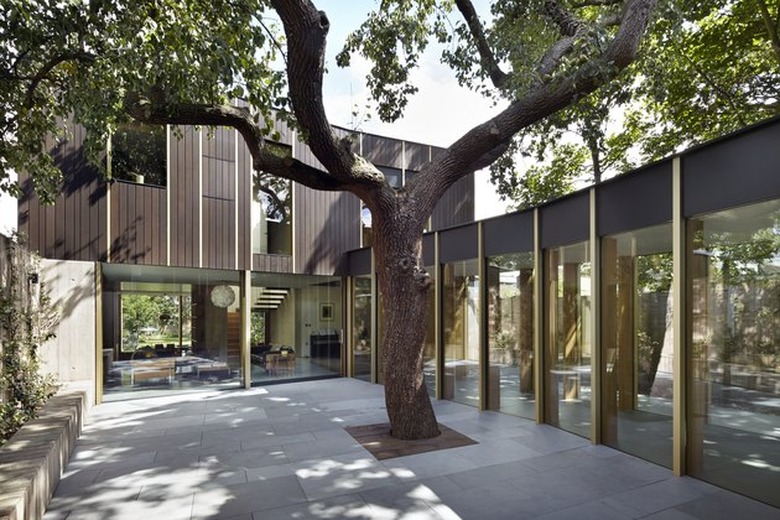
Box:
xmin=201 ymin=127 xmax=237 ymax=269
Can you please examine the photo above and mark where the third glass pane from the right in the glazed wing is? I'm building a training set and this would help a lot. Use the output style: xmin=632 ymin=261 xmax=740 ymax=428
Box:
xmin=544 ymin=242 xmax=591 ymax=437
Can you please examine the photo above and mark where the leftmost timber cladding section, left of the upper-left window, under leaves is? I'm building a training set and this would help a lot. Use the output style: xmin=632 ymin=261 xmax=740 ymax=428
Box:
xmin=18 ymin=123 xmax=108 ymax=261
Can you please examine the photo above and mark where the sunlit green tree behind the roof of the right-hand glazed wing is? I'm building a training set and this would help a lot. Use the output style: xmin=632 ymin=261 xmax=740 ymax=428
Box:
xmin=492 ymin=0 xmax=780 ymax=207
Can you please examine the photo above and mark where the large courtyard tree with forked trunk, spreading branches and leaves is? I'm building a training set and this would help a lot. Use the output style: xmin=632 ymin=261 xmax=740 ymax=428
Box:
xmin=0 ymin=0 xmax=655 ymax=439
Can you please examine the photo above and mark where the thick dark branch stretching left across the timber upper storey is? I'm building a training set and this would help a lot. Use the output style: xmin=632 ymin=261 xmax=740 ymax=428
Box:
xmin=125 ymin=96 xmax=345 ymax=191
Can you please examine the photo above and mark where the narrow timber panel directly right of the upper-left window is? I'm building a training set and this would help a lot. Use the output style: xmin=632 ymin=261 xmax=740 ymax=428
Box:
xmin=168 ymin=127 xmax=200 ymax=267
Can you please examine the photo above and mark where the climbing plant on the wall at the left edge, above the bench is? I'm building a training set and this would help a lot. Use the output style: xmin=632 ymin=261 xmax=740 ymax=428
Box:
xmin=0 ymin=241 xmax=58 ymax=444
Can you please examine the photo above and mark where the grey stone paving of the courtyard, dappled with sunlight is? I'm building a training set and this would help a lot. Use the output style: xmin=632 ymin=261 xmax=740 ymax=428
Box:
xmin=44 ymin=379 xmax=780 ymax=520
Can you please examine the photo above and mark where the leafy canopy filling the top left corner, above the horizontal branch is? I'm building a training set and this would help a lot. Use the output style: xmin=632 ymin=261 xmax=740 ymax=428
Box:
xmin=0 ymin=0 xmax=286 ymax=201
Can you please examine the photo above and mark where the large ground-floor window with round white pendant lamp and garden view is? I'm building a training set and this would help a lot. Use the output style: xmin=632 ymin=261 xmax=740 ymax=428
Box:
xmin=102 ymin=264 xmax=241 ymax=400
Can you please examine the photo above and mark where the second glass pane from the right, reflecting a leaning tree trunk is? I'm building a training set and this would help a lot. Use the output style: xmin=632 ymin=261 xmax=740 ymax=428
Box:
xmin=601 ymin=225 xmax=674 ymax=467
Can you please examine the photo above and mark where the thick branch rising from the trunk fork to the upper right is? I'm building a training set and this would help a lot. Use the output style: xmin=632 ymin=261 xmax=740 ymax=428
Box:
xmin=414 ymin=0 xmax=657 ymax=211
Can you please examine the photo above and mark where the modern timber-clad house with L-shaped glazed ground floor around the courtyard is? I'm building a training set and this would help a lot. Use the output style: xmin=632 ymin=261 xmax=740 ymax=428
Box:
xmin=15 ymin=120 xmax=780 ymax=507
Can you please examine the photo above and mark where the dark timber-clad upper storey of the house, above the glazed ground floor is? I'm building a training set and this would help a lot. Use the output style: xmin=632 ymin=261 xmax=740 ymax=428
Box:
xmin=19 ymin=117 xmax=474 ymax=274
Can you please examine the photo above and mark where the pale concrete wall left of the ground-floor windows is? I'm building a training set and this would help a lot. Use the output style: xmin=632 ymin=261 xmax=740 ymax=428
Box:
xmin=41 ymin=260 xmax=97 ymax=405
